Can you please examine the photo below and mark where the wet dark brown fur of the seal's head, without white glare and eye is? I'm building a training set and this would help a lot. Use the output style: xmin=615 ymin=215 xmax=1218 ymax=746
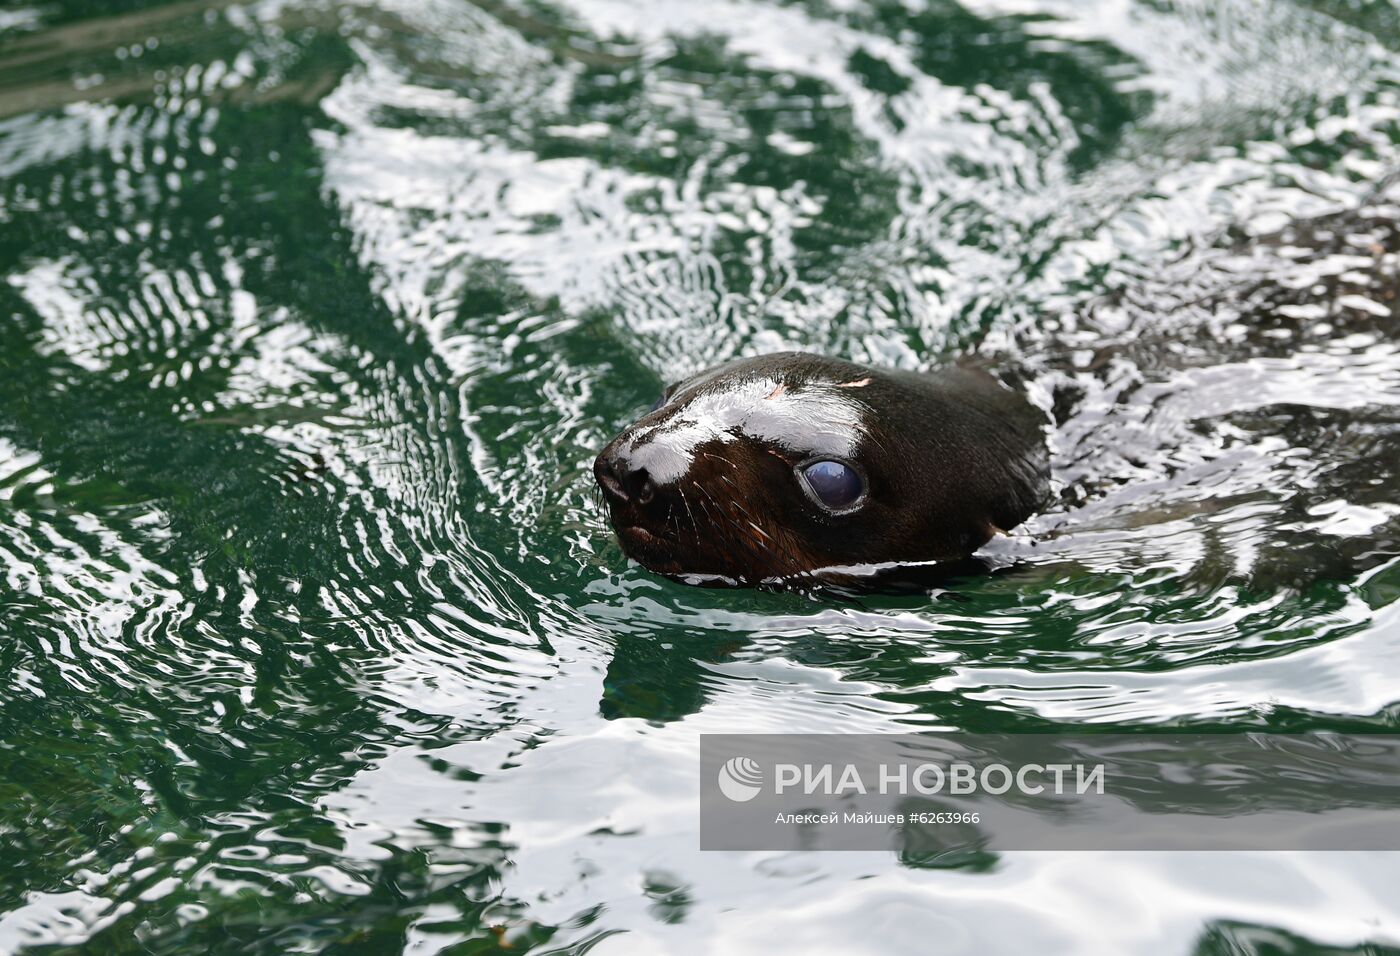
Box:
xmin=596 ymin=353 xmax=1049 ymax=585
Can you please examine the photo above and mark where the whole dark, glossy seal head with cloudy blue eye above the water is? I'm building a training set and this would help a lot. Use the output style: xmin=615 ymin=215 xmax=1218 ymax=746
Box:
xmin=594 ymin=353 xmax=1049 ymax=586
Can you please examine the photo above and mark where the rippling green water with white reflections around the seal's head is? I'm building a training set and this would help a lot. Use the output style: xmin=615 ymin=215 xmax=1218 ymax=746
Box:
xmin=0 ymin=0 xmax=1400 ymax=955
